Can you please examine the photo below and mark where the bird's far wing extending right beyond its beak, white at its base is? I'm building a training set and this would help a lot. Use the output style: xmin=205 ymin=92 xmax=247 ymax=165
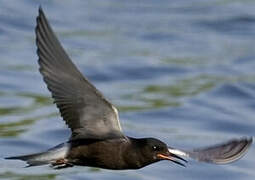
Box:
xmin=168 ymin=138 xmax=252 ymax=164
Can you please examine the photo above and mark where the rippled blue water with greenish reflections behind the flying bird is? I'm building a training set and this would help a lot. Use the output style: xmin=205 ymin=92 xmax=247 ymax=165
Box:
xmin=0 ymin=0 xmax=255 ymax=180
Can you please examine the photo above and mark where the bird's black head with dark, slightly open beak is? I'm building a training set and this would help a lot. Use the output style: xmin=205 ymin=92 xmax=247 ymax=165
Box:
xmin=132 ymin=138 xmax=186 ymax=166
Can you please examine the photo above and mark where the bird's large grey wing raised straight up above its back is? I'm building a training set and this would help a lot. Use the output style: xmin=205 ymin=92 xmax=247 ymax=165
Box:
xmin=35 ymin=7 xmax=123 ymax=139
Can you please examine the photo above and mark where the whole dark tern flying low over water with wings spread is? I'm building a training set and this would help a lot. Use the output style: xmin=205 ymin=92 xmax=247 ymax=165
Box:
xmin=6 ymin=7 xmax=252 ymax=170
